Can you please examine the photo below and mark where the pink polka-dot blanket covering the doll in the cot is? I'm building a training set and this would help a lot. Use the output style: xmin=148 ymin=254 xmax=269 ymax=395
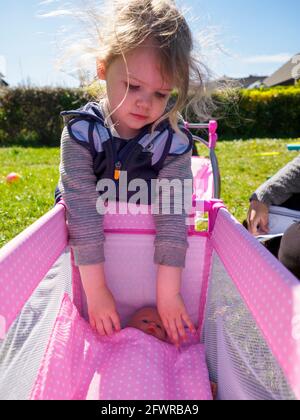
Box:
xmin=31 ymin=295 xmax=212 ymax=400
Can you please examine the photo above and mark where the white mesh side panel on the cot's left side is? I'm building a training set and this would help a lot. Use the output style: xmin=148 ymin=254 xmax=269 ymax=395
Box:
xmin=0 ymin=250 xmax=72 ymax=400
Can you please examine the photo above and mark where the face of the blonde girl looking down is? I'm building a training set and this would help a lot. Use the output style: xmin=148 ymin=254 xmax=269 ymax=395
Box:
xmin=105 ymin=43 xmax=173 ymax=138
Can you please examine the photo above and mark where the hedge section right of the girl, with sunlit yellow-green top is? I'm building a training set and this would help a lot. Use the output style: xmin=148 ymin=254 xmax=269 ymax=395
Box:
xmin=214 ymin=85 xmax=300 ymax=139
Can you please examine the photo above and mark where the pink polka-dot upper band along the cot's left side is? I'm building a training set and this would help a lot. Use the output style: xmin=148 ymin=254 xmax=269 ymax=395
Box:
xmin=0 ymin=205 xmax=67 ymax=335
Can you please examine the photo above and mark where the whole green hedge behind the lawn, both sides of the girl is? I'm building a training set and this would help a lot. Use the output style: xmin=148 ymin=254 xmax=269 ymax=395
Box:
xmin=0 ymin=86 xmax=300 ymax=146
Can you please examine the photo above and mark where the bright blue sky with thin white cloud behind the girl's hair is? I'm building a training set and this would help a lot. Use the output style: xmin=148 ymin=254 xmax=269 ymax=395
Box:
xmin=0 ymin=0 xmax=300 ymax=86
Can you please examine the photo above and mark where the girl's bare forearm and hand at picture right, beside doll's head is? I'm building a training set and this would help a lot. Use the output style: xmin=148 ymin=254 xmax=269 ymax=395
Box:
xmin=157 ymin=266 xmax=196 ymax=347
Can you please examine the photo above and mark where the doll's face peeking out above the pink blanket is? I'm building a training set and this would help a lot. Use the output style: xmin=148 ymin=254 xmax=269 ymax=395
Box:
xmin=128 ymin=308 xmax=167 ymax=341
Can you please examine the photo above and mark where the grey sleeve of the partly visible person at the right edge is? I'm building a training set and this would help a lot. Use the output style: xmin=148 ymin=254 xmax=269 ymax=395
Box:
xmin=250 ymin=156 xmax=300 ymax=206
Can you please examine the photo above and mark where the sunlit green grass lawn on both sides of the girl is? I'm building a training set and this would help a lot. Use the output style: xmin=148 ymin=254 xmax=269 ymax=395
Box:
xmin=0 ymin=139 xmax=300 ymax=247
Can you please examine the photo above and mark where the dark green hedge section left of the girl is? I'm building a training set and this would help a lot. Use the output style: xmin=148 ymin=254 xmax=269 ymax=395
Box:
xmin=0 ymin=88 xmax=90 ymax=146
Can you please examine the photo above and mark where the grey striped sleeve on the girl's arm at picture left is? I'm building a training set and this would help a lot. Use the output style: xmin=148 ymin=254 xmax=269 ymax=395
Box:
xmin=59 ymin=128 xmax=105 ymax=265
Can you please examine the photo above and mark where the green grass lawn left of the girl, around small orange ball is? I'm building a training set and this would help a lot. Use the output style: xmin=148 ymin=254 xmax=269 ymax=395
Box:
xmin=0 ymin=147 xmax=59 ymax=247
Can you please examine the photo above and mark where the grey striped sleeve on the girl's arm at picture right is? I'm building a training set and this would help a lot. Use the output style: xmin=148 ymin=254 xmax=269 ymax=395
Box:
xmin=154 ymin=151 xmax=193 ymax=267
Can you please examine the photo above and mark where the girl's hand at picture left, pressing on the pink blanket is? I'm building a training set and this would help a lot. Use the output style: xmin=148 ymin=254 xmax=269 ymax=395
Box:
xmin=87 ymin=285 xmax=121 ymax=336
